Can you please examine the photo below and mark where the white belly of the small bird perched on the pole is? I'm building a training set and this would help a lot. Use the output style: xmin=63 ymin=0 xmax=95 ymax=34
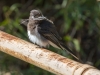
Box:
xmin=28 ymin=31 xmax=49 ymax=47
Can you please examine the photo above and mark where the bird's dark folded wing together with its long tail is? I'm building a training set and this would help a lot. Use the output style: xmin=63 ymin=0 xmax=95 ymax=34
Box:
xmin=38 ymin=20 xmax=78 ymax=59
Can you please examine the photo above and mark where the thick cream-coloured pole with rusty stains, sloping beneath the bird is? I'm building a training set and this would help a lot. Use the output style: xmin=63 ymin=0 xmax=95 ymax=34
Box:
xmin=0 ymin=31 xmax=100 ymax=75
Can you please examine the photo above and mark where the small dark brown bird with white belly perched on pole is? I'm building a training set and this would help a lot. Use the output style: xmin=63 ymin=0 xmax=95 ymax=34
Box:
xmin=22 ymin=9 xmax=79 ymax=60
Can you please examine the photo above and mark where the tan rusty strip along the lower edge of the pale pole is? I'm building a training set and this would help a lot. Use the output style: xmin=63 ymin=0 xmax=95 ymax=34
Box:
xmin=0 ymin=46 xmax=62 ymax=75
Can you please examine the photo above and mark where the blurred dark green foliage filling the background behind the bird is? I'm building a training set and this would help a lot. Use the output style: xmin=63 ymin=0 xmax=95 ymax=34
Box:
xmin=0 ymin=0 xmax=100 ymax=75
